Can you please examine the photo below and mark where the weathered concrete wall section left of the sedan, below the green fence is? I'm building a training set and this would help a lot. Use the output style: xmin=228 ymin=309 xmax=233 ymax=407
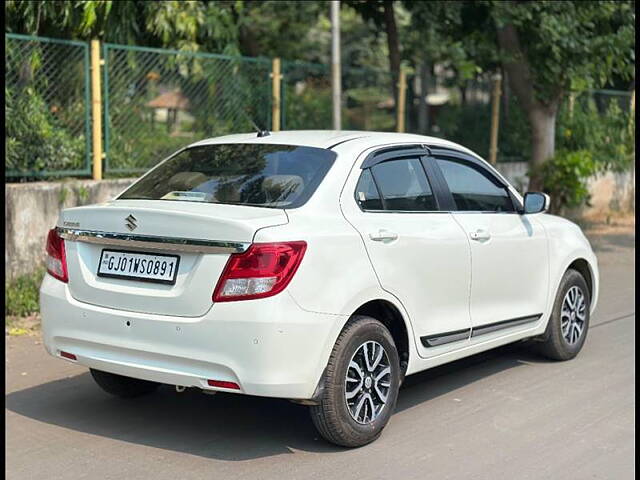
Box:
xmin=4 ymin=179 xmax=132 ymax=279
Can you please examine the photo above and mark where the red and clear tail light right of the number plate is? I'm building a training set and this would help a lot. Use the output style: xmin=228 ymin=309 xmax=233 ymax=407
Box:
xmin=213 ymin=242 xmax=307 ymax=302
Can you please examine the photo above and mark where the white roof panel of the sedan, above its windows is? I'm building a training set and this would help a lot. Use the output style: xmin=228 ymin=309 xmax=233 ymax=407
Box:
xmin=185 ymin=130 xmax=478 ymax=157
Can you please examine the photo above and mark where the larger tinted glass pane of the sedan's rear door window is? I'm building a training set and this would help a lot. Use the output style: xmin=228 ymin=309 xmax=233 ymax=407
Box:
xmin=371 ymin=158 xmax=438 ymax=212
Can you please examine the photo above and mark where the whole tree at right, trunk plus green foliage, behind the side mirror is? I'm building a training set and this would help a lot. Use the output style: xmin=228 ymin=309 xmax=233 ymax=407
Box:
xmin=488 ymin=0 xmax=635 ymax=188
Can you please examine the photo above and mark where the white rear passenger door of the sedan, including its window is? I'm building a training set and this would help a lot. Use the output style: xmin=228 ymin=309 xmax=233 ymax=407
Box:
xmin=341 ymin=150 xmax=471 ymax=356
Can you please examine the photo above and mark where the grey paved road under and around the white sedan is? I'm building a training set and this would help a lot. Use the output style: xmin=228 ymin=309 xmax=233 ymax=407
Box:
xmin=6 ymin=231 xmax=635 ymax=480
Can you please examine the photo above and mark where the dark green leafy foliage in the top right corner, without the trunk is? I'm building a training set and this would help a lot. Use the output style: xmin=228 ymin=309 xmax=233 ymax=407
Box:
xmin=490 ymin=0 xmax=635 ymax=104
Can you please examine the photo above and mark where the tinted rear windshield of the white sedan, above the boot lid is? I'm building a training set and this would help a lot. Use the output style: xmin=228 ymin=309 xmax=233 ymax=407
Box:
xmin=118 ymin=143 xmax=336 ymax=208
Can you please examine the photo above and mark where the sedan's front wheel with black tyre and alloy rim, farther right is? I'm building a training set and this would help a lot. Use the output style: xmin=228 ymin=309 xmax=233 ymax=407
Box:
xmin=539 ymin=269 xmax=591 ymax=360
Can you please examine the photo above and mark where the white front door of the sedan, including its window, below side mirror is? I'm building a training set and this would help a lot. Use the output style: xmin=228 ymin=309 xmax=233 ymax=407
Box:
xmin=434 ymin=151 xmax=549 ymax=339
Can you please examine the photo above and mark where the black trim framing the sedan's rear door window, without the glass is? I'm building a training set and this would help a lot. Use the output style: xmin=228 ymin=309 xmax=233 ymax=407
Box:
xmin=353 ymin=144 xmax=449 ymax=214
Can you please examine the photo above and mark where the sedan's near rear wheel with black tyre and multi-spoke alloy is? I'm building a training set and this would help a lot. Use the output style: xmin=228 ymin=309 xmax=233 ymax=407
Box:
xmin=310 ymin=316 xmax=401 ymax=447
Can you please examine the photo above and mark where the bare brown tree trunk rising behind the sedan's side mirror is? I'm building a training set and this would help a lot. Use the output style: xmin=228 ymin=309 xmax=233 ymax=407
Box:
xmin=527 ymin=104 xmax=558 ymax=191
